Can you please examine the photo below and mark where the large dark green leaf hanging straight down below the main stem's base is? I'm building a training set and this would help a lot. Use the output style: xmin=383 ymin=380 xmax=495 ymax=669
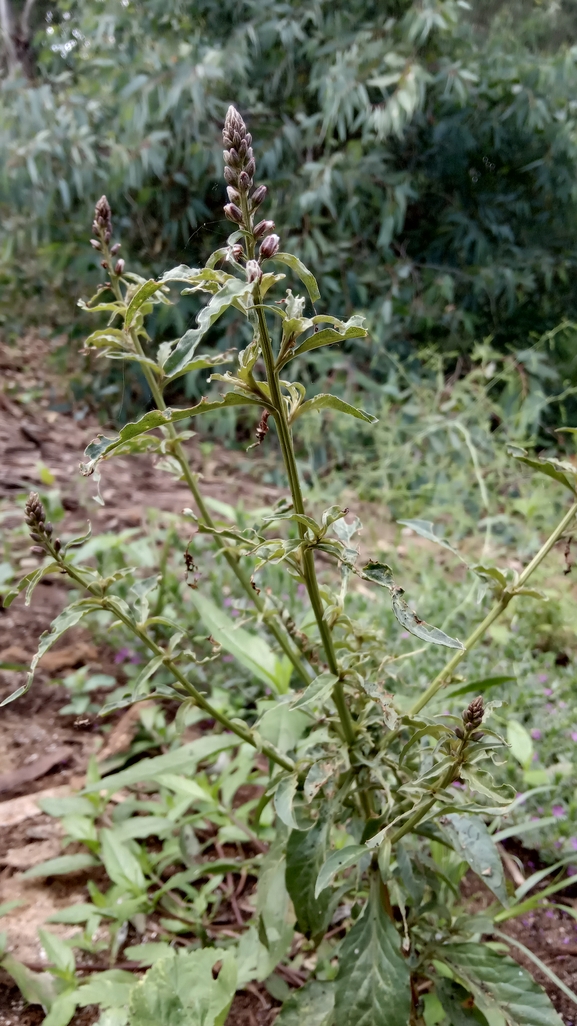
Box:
xmin=335 ymin=877 xmax=411 ymax=1026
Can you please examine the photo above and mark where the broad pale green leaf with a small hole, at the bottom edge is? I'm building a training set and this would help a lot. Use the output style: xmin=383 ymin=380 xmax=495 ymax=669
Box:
xmin=129 ymin=948 xmax=237 ymax=1026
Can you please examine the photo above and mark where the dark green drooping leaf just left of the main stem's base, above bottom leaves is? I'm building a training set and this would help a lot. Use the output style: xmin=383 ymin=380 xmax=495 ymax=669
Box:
xmin=286 ymin=816 xmax=332 ymax=938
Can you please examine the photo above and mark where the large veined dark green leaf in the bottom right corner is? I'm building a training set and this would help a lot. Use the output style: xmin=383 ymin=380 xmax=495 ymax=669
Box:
xmin=436 ymin=944 xmax=562 ymax=1026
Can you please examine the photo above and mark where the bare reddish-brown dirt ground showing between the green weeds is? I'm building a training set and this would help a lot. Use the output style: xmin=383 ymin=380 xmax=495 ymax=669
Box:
xmin=0 ymin=339 xmax=577 ymax=1026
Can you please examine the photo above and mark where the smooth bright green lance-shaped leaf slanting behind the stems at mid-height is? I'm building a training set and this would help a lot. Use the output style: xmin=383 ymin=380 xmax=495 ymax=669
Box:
xmin=190 ymin=591 xmax=293 ymax=695
